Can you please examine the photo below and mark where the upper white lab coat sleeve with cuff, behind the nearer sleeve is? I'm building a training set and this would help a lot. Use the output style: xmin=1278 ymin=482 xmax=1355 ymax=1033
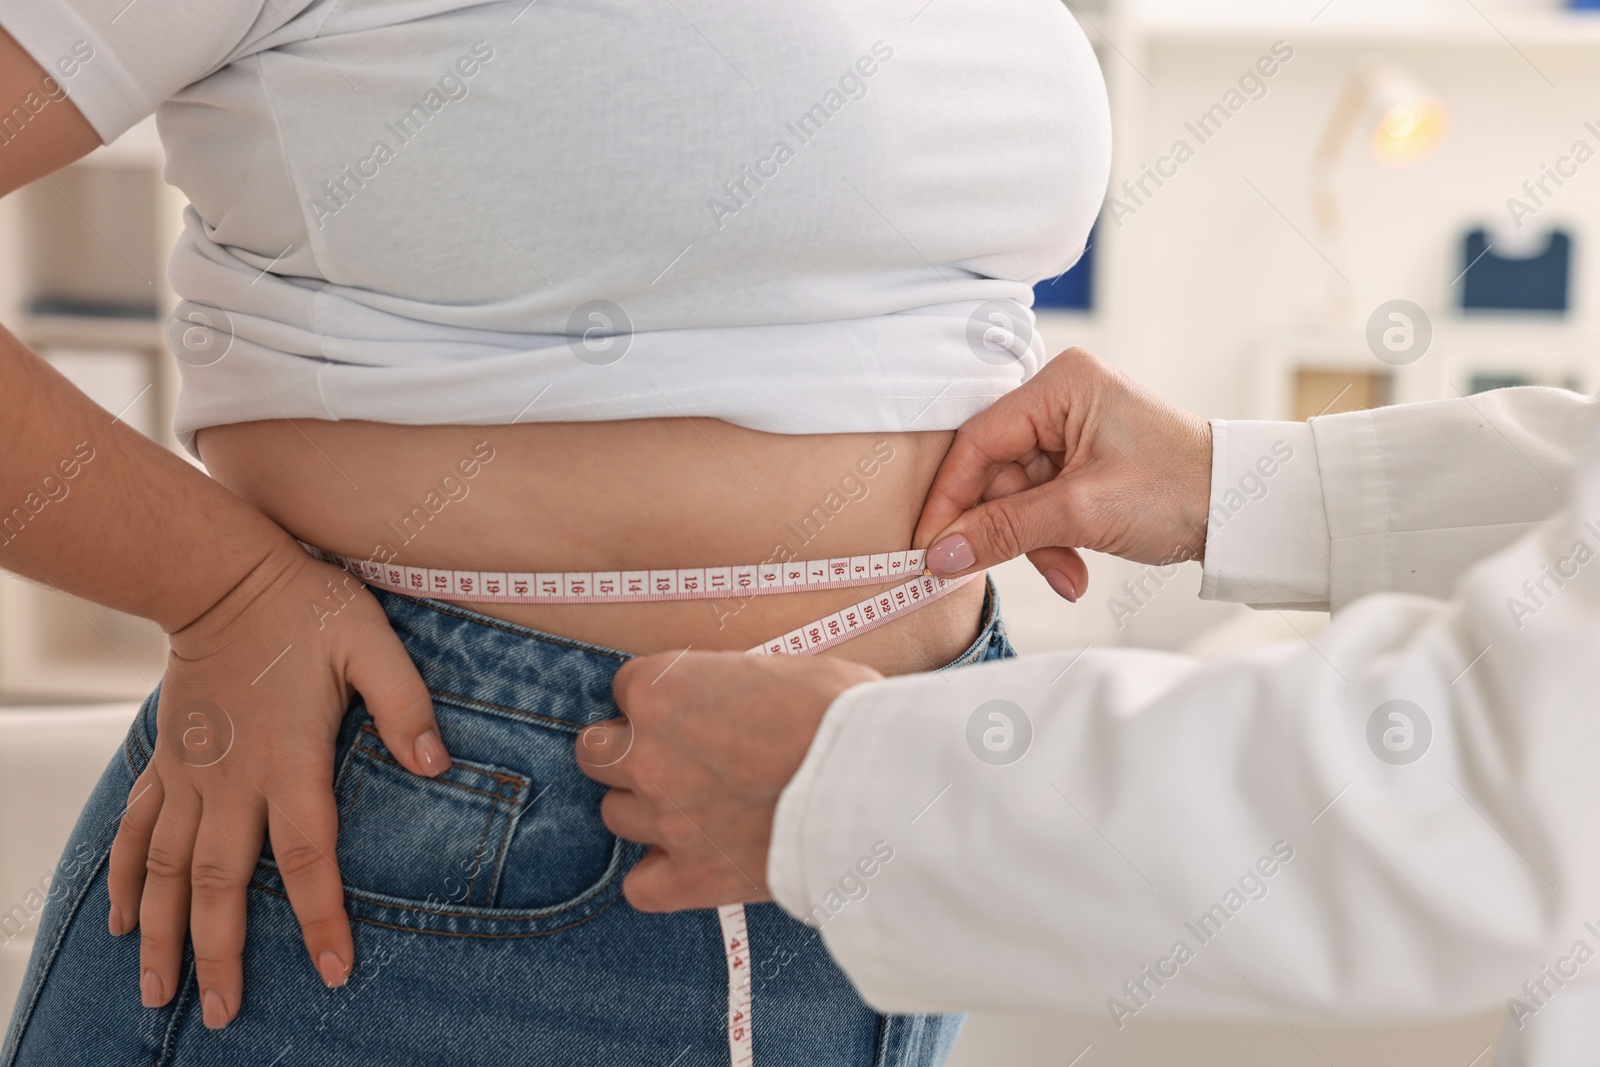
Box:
xmin=1200 ymin=387 xmax=1595 ymax=609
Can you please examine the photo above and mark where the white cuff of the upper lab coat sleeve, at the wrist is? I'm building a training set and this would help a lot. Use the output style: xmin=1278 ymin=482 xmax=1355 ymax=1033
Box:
xmin=1200 ymin=419 xmax=1330 ymax=609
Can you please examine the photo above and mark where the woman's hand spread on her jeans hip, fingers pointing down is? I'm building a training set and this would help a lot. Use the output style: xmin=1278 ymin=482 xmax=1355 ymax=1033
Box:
xmin=110 ymin=544 xmax=450 ymax=1029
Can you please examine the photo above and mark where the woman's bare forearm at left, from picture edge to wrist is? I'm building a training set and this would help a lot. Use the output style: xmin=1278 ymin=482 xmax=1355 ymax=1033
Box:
xmin=0 ymin=328 xmax=294 ymax=632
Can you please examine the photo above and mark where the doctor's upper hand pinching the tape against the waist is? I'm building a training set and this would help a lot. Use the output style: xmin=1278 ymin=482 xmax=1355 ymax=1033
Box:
xmin=912 ymin=349 xmax=1211 ymax=600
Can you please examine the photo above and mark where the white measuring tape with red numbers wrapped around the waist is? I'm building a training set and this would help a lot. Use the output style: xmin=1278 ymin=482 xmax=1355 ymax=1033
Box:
xmin=301 ymin=541 xmax=978 ymax=1067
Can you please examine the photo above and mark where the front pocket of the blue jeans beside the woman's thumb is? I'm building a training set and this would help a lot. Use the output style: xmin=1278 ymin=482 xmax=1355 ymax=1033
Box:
xmin=256 ymin=691 xmax=642 ymax=937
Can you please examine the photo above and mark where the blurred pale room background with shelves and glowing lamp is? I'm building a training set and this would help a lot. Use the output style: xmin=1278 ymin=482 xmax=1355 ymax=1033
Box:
xmin=0 ymin=0 xmax=1600 ymax=1067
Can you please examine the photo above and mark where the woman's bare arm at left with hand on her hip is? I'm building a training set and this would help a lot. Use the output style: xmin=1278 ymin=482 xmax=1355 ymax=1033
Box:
xmin=0 ymin=22 xmax=450 ymax=1027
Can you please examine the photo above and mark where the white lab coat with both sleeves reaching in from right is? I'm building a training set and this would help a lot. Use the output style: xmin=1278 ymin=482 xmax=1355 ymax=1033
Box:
xmin=768 ymin=389 xmax=1600 ymax=1064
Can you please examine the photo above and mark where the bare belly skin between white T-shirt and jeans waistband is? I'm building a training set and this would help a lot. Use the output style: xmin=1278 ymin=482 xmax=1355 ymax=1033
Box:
xmin=197 ymin=419 xmax=982 ymax=673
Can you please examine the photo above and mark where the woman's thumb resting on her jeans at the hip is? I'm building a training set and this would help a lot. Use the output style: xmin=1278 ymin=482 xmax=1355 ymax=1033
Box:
xmin=344 ymin=605 xmax=450 ymax=777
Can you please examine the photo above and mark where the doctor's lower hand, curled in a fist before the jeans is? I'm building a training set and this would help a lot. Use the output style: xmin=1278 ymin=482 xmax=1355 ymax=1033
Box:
xmin=578 ymin=653 xmax=882 ymax=912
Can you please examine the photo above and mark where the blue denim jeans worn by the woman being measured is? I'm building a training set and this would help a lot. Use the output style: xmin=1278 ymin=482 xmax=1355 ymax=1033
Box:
xmin=0 ymin=587 xmax=1016 ymax=1067
